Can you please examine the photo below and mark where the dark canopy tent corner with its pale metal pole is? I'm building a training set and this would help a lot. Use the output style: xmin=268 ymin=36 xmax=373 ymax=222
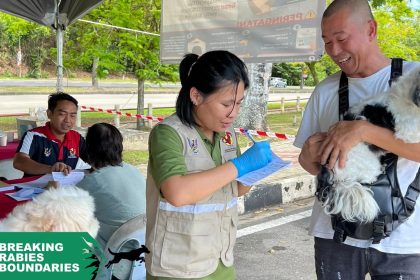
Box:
xmin=0 ymin=0 xmax=103 ymax=91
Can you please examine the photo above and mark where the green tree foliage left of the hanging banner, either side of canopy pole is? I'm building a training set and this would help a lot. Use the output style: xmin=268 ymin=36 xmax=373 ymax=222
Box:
xmin=0 ymin=0 xmax=178 ymax=82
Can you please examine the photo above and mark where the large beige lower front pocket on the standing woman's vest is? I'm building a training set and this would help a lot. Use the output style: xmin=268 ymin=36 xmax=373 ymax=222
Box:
xmin=161 ymin=219 xmax=219 ymax=272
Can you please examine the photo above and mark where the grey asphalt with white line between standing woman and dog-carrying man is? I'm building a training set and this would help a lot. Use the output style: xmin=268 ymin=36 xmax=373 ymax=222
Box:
xmin=235 ymin=198 xmax=316 ymax=280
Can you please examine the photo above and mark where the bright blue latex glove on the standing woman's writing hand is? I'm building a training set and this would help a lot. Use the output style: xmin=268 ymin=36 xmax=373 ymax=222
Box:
xmin=230 ymin=141 xmax=271 ymax=177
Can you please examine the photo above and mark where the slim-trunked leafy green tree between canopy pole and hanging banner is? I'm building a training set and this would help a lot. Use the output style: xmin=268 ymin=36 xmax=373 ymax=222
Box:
xmin=71 ymin=0 xmax=177 ymax=128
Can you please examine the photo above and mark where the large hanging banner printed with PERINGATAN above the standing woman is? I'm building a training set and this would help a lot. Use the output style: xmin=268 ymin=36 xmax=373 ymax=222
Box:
xmin=160 ymin=0 xmax=325 ymax=63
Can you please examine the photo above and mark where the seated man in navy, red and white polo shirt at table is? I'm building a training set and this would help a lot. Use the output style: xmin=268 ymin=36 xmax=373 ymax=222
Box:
xmin=13 ymin=92 xmax=85 ymax=177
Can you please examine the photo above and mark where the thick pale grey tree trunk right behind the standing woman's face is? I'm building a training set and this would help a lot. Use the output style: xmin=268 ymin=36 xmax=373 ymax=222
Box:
xmin=235 ymin=63 xmax=273 ymax=131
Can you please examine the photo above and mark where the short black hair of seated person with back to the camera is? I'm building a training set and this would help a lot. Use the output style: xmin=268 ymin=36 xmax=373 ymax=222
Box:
xmin=86 ymin=123 xmax=123 ymax=169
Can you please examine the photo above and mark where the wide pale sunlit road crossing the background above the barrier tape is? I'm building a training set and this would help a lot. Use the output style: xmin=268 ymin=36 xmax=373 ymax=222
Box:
xmin=0 ymin=93 xmax=310 ymax=115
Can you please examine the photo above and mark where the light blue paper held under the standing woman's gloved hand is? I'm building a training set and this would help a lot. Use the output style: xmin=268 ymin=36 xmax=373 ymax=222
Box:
xmin=236 ymin=152 xmax=292 ymax=186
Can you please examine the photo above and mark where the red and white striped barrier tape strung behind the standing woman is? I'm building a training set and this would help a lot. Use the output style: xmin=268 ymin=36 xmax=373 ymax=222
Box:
xmin=80 ymin=106 xmax=294 ymax=140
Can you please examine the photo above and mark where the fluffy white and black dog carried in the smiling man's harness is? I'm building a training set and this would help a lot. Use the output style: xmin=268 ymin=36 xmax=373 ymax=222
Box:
xmin=321 ymin=66 xmax=420 ymax=223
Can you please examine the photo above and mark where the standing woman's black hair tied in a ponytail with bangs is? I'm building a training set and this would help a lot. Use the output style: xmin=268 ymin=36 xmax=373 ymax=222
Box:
xmin=176 ymin=50 xmax=249 ymax=126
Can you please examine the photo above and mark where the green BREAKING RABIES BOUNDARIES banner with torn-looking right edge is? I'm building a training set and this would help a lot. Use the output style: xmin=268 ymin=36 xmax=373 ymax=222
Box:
xmin=0 ymin=232 xmax=109 ymax=280
